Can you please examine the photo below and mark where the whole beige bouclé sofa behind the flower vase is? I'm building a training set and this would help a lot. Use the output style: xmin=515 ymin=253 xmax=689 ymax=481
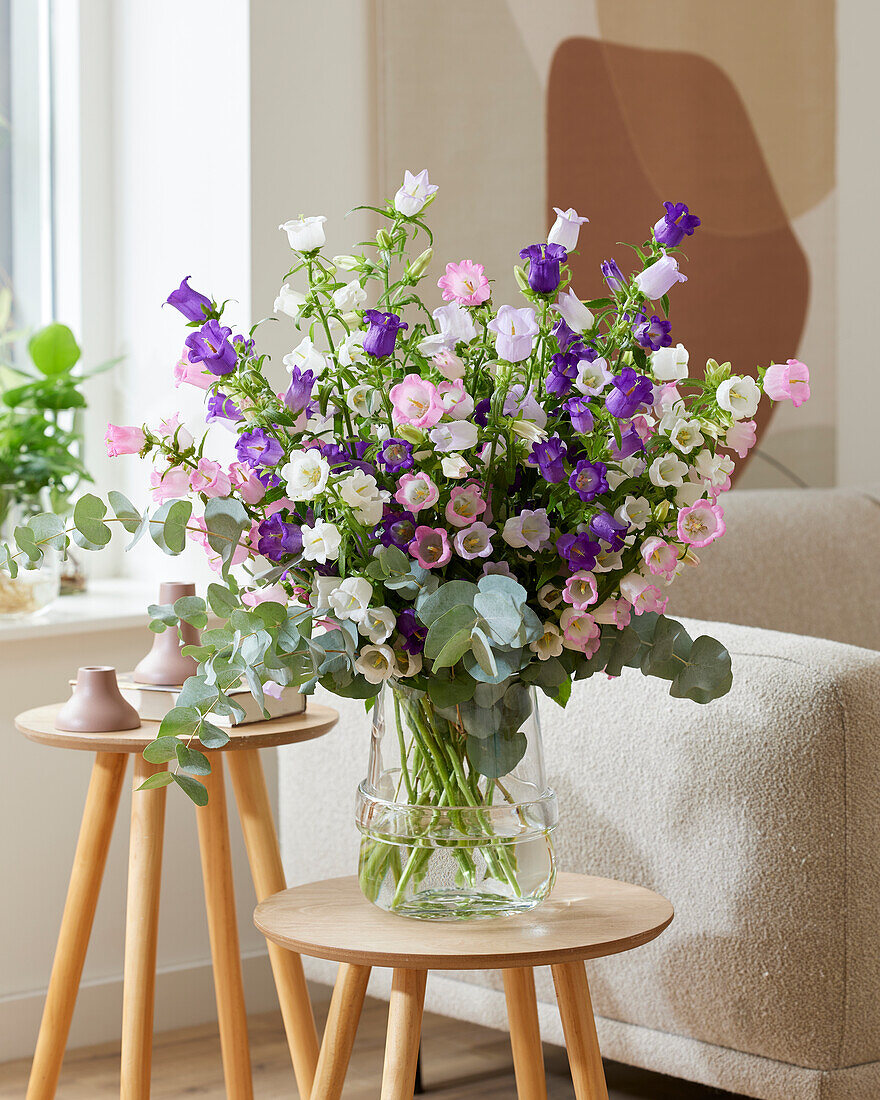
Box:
xmin=281 ymin=492 xmax=880 ymax=1100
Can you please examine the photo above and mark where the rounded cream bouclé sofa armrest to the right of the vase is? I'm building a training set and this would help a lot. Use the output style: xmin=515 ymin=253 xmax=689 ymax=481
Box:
xmin=542 ymin=620 xmax=880 ymax=1068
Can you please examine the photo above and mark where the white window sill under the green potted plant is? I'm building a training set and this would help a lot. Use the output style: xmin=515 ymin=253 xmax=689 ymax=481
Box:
xmin=0 ymin=579 xmax=156 ymax=645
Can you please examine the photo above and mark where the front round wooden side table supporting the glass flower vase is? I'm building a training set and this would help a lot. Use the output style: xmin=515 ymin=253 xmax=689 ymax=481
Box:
xmin=254 ymin=875 xmax=673 ymax=1100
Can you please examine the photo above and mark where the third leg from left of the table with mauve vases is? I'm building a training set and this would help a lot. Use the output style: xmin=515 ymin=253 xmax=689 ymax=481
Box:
xmin=196 ymin=752 xmax=253 ymax=1100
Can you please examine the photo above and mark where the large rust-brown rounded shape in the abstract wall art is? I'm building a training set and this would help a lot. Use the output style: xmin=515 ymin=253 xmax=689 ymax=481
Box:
xmin=547 ymin=39 xmax=810 ymax=469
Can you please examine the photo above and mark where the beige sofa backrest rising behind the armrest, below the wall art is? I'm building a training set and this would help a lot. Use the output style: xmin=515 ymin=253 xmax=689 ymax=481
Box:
xmin=669 ymin=490 xmax=880 ymax=650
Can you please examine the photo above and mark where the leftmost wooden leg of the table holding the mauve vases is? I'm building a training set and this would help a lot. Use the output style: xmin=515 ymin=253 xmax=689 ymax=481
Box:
xmin=28 ymin=752 xmax=128 ymax=1100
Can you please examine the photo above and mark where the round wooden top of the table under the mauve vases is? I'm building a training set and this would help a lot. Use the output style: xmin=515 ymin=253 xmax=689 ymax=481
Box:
xmin=15 ymin=702 xmax=339 ymax=752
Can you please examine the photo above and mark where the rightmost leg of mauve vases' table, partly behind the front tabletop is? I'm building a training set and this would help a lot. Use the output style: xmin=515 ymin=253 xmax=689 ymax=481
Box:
xmin=224 ymin=749 xmax=321 ymax=1100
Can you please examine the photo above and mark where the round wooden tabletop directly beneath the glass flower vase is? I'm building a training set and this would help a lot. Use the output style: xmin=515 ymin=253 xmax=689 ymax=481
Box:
xmin=254 ymin=873 xmax=673 ymax=970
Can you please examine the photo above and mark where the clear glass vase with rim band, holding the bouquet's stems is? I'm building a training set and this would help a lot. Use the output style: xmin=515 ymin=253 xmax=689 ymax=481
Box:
xmin=356 ymin=678 xmax=558 ymax=921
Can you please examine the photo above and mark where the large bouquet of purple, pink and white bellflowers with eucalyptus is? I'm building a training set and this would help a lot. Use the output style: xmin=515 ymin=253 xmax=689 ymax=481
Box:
xmin=1 ymin=172 xmax=810 ymax=910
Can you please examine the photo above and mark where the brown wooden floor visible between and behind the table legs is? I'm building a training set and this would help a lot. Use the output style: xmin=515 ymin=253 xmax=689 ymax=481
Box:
xmin=0 ymin=987 xmax=735 ymax=1100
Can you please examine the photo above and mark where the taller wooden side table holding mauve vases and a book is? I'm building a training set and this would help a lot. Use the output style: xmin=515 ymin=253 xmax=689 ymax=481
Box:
xmin=15 ymin=703 xmax=339 ymax=1100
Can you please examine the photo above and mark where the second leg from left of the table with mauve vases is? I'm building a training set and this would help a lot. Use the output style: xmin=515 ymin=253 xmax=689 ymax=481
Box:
xmin=119 ymin=754 xmax=168 ymax=1100
